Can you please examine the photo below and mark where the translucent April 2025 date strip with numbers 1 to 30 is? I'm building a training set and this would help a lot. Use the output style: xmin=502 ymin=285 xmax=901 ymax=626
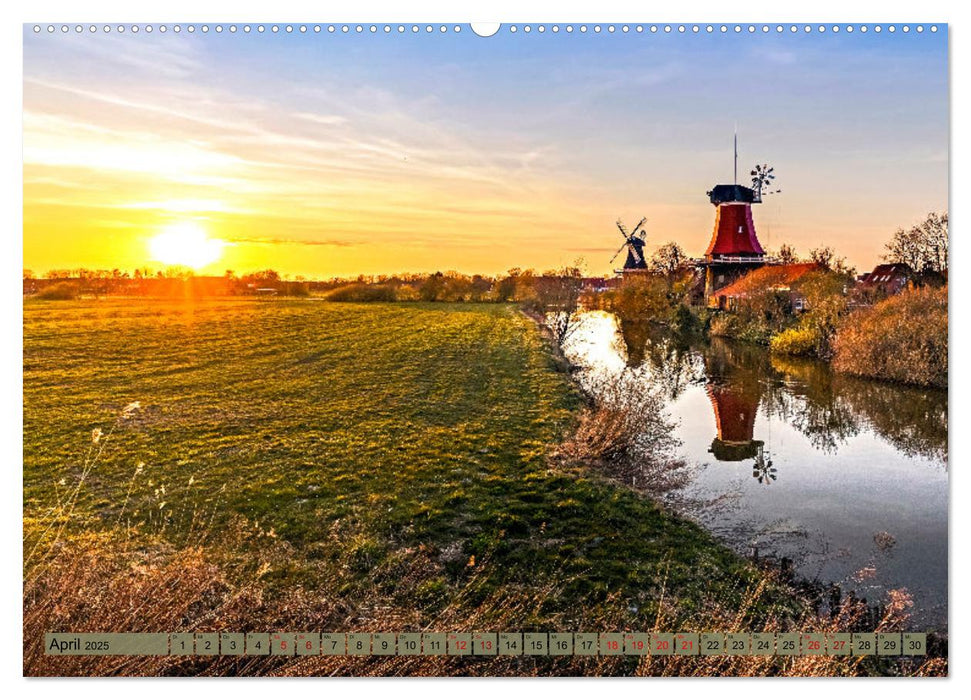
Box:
xmin=44 ymin=632 xmax=927 ymax=657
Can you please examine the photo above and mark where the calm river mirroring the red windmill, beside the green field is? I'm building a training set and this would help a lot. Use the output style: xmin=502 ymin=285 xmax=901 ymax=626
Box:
xmin=565 ymin=312 xmax=947 ymax=628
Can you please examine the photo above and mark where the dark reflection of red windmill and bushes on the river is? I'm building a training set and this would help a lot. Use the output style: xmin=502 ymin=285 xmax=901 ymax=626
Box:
xmin=616 ymin=321 xmax=947 ymax=470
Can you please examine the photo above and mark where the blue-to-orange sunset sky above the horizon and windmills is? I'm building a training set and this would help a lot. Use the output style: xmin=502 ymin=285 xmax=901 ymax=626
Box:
xmin=23 ymin=25 xmax=949 ymax=278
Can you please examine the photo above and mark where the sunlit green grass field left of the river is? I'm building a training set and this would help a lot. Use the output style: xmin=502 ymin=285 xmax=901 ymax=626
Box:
xmin=24 ymin=300 xmax=888 ymax=672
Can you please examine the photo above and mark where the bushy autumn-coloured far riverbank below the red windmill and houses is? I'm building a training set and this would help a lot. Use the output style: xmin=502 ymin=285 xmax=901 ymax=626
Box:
xmin=582 ymin=268 xmax=948 ymax=388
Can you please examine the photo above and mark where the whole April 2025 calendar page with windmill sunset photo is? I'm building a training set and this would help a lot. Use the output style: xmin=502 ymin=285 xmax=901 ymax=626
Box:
xmin=22 ymin=17 xmax=950 ymax=677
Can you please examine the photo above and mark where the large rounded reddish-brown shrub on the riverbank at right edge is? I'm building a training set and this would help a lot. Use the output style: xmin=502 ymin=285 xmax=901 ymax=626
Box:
xmin=833 ymin=287 xmax=947 ymax=387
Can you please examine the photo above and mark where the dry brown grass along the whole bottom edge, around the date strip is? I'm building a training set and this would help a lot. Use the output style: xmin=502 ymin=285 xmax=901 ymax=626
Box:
xmin=24 ymin=528 xmax=947 ymax=676
